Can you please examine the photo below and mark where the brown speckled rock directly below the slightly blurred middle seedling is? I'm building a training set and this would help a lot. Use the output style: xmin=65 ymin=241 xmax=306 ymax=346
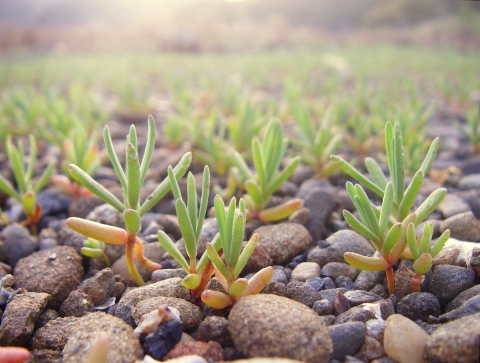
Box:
xmin=254 ymin=223 xmax=312 ymax=265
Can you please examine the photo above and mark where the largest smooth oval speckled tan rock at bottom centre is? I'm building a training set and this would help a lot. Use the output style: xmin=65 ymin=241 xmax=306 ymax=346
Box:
xmin=228 ymin=294 xmax=333 ymax=363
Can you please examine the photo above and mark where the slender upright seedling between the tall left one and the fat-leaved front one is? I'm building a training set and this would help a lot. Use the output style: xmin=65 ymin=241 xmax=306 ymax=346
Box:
xmin=157 ymin=166 xmax=218 ymax=301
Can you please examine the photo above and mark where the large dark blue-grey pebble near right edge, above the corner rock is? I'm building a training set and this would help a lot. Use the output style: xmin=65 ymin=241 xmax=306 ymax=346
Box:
xmin=429 ymin=265 xmax=475 ymax=306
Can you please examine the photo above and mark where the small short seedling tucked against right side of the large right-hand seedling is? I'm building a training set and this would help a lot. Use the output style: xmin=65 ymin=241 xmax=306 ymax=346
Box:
xmin=403 ymin=222 xmax=450 ymax=292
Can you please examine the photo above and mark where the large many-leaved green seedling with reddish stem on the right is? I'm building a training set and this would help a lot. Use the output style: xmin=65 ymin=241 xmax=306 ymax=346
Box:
xmin=332 ymin=122 xmax=447 ymax=294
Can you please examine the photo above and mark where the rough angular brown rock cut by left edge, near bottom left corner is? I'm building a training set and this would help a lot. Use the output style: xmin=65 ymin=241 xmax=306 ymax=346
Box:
xmin=0 ymin=292 xmax=50 ymax=346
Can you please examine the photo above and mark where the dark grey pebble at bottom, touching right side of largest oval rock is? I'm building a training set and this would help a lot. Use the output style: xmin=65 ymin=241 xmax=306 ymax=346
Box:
xmin=328 ymin=322 xmax=367 ymax=361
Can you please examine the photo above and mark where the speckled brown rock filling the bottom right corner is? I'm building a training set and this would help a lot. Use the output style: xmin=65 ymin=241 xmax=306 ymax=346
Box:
xmin=425 ymin=313 xmax=480 ymax=363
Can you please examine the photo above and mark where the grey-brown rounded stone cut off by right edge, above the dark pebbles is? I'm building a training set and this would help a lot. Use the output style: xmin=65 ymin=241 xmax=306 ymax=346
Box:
xmin=440 ymin=212 xmax=480 ymax=242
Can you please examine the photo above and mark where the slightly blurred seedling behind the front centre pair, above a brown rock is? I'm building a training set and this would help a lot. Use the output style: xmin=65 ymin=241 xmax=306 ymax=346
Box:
xmin=232 ymin=121 xmax=302 ymax=222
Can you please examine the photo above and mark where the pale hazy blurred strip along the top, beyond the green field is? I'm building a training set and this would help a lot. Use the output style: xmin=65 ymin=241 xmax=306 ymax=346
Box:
xmin=0 ymin=0 xmax=480 ymax=53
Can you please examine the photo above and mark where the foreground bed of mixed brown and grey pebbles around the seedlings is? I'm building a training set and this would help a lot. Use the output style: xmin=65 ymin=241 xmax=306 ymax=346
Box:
xmin=0 ymin=111 xmax=480 ymax=363
